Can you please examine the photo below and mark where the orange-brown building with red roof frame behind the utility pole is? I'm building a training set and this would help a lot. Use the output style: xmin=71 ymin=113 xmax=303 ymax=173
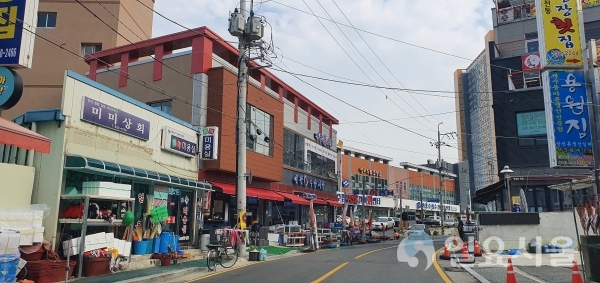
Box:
xmin=86 ymin=27 xmax=340 ymax=231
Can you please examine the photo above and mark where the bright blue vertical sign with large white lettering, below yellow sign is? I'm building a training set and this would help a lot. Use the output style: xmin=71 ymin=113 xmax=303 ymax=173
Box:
xmin=544 ymin=71 xmax=594 ymax=167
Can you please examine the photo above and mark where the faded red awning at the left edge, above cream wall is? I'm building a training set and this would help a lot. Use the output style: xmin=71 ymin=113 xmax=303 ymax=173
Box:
xmin=0 ymin=117 xmax=52 ymax=154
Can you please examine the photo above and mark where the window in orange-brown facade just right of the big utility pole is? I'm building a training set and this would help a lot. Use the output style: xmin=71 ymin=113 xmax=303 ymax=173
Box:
xmin=246 ymin=104 xmax=273 ymax=156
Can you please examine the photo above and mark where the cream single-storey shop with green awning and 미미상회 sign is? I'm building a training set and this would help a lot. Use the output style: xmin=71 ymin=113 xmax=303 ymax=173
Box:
xmin=24 ymin=71 xmax=212 ymax=253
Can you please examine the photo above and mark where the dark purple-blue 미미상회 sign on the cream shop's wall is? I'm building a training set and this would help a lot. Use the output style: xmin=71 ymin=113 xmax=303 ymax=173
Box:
xmin=81 ymin=96 xmax=150 ymax=141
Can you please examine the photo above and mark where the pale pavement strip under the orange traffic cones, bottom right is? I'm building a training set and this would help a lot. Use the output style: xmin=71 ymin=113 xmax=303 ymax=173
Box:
xmin=437 ymin=251 xmax=581 ymax=283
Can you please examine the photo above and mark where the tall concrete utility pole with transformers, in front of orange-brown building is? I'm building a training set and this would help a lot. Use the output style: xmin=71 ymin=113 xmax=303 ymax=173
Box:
xmin=229 ymin=0 xmax=263 ymax=257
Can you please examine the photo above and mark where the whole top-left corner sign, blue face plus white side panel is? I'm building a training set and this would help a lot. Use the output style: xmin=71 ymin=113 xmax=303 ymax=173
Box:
xmin=0 ymin=0 xmax=39 ymax=68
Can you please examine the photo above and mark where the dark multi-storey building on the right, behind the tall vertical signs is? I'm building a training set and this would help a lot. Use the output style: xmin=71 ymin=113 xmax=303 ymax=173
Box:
xmin=454 ymin=0 xmax=600 ymax=212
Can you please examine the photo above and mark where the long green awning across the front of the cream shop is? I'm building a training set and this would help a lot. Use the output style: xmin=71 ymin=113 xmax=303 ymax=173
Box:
xmin=65 ymin=155 xmax=212 ymax=190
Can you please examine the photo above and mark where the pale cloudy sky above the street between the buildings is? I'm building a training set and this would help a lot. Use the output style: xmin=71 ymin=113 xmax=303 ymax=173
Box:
xmin=153 ymin=0 xmax=494 ymax=165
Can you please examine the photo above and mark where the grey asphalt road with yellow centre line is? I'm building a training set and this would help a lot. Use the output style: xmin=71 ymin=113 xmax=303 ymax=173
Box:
xmin=185 ymin=238 xmax=445 ymax=283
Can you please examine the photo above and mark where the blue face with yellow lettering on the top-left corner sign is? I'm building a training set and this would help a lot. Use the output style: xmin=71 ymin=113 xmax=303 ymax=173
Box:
xmin=0 ymin=0 xmax=26 ymax=66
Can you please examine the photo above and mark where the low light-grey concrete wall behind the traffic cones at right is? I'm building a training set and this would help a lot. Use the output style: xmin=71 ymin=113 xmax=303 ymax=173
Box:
xmin=479 ymin=212 xmax=581 ymax=251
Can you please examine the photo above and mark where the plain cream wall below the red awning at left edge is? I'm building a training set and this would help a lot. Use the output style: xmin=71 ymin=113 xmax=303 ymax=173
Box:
xmin=0 ymin=163 xmax=35 ymax=208
